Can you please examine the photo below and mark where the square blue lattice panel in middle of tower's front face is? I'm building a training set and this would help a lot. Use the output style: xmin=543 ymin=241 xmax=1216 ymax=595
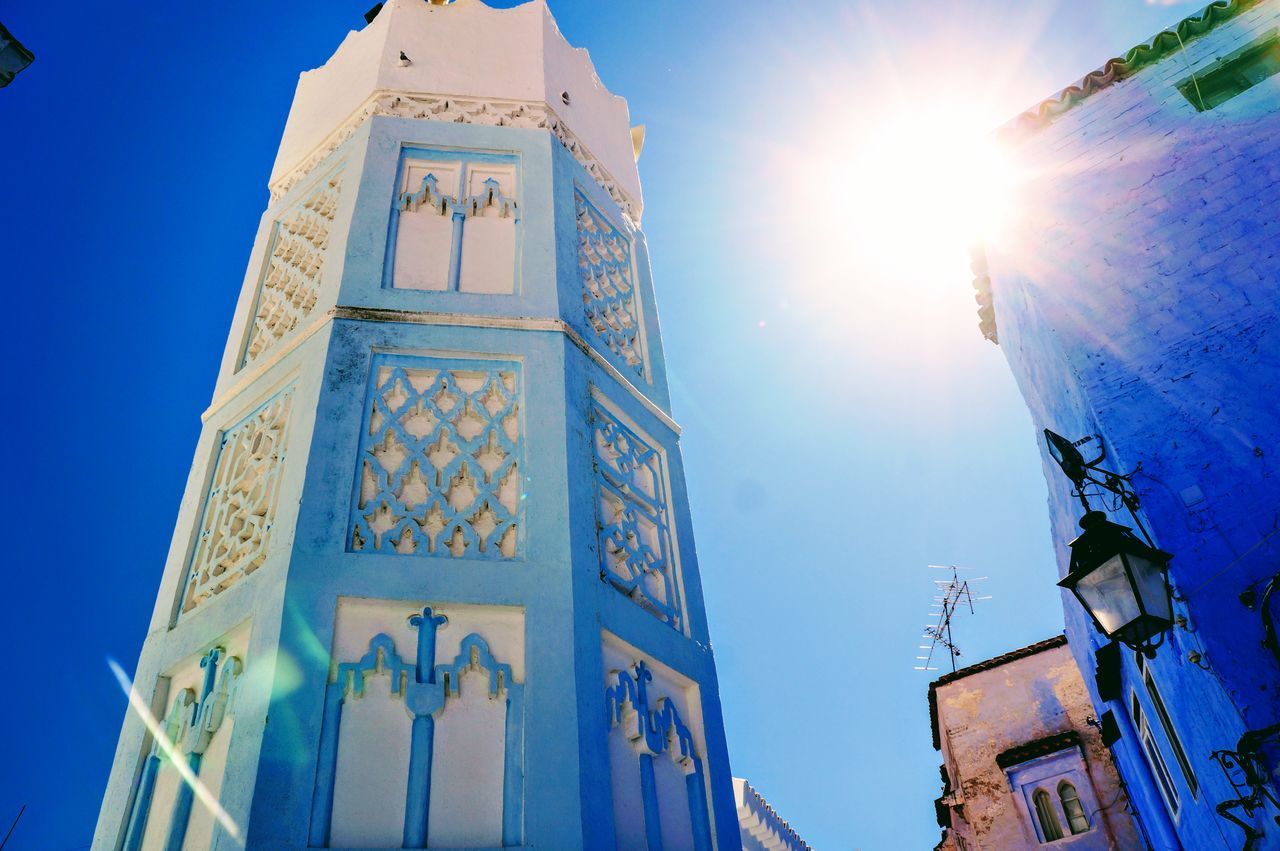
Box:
xmin=348 ymin=354 xmax=524 ymax=559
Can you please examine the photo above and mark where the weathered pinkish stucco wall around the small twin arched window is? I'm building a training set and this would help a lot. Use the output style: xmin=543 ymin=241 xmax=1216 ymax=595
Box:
xmin=933 ymin=639 xmax=1139 ymax=851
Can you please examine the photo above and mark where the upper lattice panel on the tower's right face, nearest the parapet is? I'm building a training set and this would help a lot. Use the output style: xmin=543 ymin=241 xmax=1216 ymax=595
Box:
xmin=573 ymin=192 xmax=644 ymax=378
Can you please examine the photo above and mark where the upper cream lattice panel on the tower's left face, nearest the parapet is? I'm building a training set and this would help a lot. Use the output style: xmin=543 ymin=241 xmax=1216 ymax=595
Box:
xmin=241 ymin=173 xmax=342 ymax=366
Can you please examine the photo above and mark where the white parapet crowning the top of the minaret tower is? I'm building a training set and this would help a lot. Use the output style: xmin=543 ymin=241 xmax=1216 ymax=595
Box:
xmin=270 ymin=0 xmax=640 ymax=218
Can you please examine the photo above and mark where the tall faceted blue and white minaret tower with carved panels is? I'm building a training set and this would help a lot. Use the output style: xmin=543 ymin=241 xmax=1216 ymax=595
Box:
xmin=93 ymin=0 xmax=740 ymax=851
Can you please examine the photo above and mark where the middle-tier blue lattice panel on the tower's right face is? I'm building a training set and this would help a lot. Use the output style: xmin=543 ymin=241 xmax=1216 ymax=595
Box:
xmin=591 ymin=399 xmax=681 ymax=630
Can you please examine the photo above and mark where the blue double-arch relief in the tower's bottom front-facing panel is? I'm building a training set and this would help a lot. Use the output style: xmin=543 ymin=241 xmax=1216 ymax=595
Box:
xmin=311 ymin=607 xmax=525 ymax=848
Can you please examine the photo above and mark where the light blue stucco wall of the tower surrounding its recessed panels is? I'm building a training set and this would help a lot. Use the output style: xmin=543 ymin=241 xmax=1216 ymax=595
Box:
xmin=93 ymin=95 xmax=739 ymax=848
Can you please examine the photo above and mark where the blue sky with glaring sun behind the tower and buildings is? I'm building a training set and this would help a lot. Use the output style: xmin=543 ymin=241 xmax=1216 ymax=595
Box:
xmin=0 ymin=0 xmax=1197 ymax=851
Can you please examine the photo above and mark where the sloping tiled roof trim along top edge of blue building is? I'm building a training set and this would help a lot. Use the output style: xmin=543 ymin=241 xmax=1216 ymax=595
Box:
xmin=1004 ymin=0 xmax=1262 ymax=132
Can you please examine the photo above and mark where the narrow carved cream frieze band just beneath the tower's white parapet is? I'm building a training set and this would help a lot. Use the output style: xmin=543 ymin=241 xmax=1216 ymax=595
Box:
xmin=271 ymin=91 xmax=641 ymax=221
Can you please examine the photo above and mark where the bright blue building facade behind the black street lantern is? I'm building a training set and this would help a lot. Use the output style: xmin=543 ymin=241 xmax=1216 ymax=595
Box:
xmin=974 ymin=0 xmax=1280 ymax=851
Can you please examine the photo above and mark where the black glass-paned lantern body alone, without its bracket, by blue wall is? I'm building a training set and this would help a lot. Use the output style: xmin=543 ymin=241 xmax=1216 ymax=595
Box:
xmin=1059 ymin=511 xmax=1174 ymax=658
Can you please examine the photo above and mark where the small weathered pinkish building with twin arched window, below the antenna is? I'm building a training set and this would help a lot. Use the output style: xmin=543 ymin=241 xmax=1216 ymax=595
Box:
xmin=929 ymin=635 xmax=1142 ymax=851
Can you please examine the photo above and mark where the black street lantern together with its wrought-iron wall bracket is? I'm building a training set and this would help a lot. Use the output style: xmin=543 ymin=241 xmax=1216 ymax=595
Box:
xmin=1044 ymin=429 xmax=1174 ymax=658
